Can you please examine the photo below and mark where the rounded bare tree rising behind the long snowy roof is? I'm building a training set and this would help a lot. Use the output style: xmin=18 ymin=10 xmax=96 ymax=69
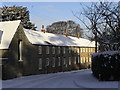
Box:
xmin=46 ymin=20 xmax=83 ymax=37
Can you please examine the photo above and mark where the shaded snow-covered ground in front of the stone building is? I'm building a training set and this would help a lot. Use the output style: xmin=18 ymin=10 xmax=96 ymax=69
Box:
xmin=2 ymin=70 xmax=119 ymax=88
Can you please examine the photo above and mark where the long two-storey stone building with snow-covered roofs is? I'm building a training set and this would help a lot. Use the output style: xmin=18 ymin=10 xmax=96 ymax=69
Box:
xmin=0 ymin=20 xmax=95 ymax=79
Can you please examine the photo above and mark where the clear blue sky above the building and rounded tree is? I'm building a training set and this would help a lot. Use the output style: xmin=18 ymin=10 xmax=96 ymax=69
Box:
xmin=1 ymin=2 xmax=91 ymax=30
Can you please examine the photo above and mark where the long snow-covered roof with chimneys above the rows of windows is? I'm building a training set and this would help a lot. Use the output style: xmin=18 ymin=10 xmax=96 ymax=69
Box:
xmin=24 ymin=29 xmax=95 ymax=47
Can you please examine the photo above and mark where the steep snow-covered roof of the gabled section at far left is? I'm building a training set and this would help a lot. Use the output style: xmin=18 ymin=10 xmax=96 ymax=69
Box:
xmin=0 ymin=20 xmax=20 ymax=49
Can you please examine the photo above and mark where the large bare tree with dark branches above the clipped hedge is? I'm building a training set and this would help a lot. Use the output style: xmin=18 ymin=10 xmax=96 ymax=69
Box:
xmin=73 ymin=2 xmax=120 ymax=51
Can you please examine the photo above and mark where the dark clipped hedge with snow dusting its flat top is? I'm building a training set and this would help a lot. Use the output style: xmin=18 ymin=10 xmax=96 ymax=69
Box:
xmin=92 ymin=51 xmax=120 ymax=80
